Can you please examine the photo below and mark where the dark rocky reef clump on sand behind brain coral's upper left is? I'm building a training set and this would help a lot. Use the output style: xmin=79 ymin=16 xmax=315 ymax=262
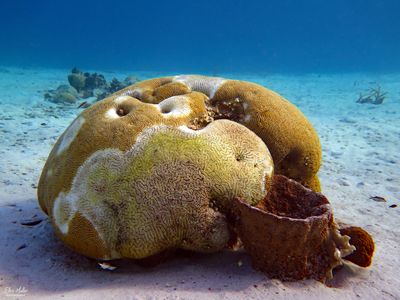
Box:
xmin=44 ymin=68 xmax=139 ymax=107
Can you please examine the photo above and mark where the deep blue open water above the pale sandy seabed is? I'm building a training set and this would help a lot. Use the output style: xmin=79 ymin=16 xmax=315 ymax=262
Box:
xmin=0 ymin=0 xmax=400 ymax=73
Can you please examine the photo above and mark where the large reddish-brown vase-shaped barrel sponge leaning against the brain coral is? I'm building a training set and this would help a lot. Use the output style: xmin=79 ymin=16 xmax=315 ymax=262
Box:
xmin=233 ymin=175 xmax=354 ymax=281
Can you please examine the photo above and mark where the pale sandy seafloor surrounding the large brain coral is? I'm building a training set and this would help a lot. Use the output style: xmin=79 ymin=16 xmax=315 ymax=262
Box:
xmin=0 ymin=67 xmax=400 ymax=299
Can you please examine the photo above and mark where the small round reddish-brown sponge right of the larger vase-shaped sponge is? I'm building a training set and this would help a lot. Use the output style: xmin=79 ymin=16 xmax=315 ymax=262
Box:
xmin=340 ymin=226 xmax=375 ymax=267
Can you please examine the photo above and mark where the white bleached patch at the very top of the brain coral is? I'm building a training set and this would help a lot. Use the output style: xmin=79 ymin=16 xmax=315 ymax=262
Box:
xmin=173 ymin=75 xmax=226 ymax=99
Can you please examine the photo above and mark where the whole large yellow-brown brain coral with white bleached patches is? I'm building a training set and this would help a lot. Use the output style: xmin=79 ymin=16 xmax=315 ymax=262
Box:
xmin=38 ymin=75 xmax=321 ymax=259
